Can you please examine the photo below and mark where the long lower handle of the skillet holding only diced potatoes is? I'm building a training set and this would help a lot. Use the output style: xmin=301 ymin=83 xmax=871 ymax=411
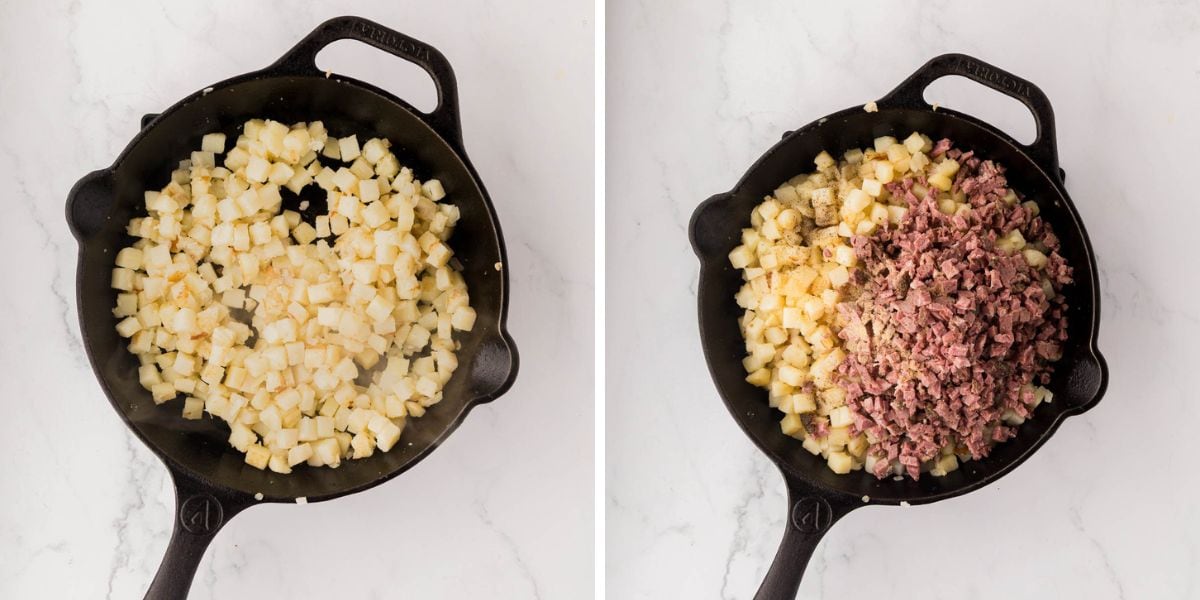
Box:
xmin=145 ymin=469 xmax=250 ymax=600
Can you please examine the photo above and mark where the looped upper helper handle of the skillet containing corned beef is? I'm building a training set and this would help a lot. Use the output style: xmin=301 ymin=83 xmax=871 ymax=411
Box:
xmin=878 ymin=53 xmax=1060 ymax=176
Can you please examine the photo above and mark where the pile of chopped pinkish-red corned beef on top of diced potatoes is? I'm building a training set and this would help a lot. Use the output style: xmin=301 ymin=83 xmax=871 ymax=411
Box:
xmin=838 ymin=140 xmax=1072 ymax=479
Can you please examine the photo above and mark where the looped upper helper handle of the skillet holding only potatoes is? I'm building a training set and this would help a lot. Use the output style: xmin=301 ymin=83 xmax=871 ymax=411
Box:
xmin=268 ymin=17 xmax=462 ymax=148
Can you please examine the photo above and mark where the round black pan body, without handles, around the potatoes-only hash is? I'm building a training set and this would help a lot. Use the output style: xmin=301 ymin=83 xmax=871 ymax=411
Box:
xmin=72 ymin=77 xmax=515 ymax=500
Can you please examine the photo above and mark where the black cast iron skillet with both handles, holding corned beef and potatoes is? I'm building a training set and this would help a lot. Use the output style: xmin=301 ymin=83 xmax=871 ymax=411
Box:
xmin=690 ymin=54 xmax=1108 ymax=599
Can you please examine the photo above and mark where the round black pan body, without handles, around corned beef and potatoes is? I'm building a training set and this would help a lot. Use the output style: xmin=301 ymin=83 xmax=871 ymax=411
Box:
xmin=692 ymin=107 xmax=1105 ymax=503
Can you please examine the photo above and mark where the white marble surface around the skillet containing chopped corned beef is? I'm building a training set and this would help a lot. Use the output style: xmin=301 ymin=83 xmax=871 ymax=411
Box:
xmin=606 ymin=0 xmax=1200 ymax=600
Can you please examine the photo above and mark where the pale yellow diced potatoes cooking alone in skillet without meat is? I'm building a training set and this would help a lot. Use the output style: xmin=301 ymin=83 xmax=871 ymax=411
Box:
xmin=112 ymin=120 xmax=475 ymax=473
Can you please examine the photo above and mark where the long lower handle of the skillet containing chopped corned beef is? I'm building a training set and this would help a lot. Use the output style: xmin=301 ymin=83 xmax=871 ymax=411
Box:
xmin=754 ymin=473 xmax=865 ymax=600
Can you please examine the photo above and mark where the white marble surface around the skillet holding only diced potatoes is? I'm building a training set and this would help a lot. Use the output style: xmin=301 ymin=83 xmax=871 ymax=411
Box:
xmin=0 ymin=1 xmax=594 ymax=599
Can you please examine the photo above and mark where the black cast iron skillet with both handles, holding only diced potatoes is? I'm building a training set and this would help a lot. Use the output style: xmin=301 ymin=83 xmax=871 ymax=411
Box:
xmin=67 ymin=17 xmax=517 ymax=599
